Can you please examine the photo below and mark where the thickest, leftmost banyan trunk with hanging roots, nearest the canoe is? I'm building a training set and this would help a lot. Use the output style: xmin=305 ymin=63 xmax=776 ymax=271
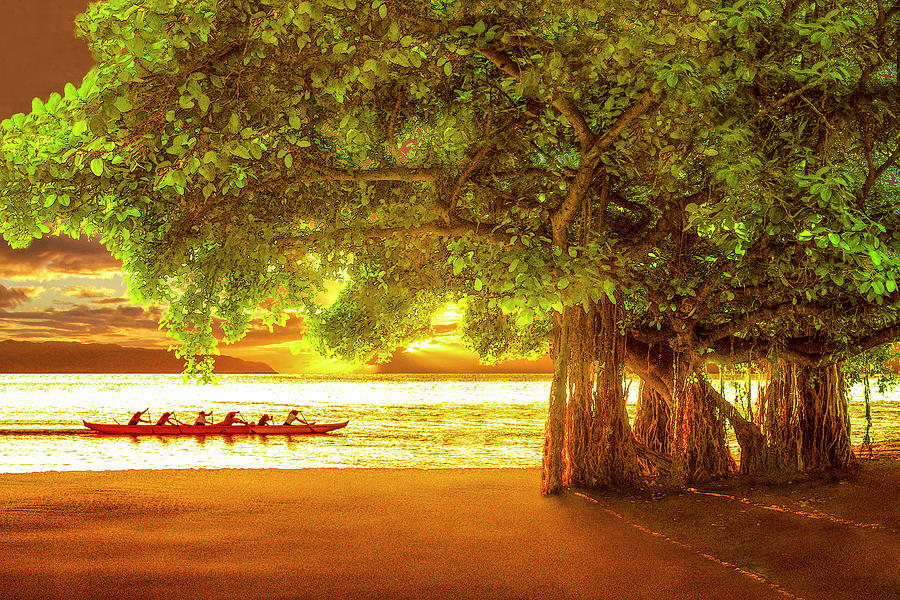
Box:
xmin=542 ymin=299 xmax=638 ymax=494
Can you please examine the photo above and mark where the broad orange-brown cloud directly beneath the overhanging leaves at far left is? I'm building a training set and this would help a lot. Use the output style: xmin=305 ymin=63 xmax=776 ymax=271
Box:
xmin=0 ymin=236 xmax=122 ymax=281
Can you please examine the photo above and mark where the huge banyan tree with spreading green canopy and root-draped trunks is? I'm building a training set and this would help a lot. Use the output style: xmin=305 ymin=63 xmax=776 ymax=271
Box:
xmin=0 ymin=0 xmax=900 ymax=493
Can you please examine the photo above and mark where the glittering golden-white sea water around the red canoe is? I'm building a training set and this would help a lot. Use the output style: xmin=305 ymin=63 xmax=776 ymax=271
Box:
xmin=0 ymin=375 xmax=900 ymax=473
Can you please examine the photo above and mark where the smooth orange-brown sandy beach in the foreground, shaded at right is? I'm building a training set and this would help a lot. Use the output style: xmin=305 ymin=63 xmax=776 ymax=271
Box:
xmin=0 ymin=461 xmax=900 ymax=600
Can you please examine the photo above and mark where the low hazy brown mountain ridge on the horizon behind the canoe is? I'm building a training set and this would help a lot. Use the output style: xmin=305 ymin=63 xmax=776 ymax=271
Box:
xmin=0 ymin=340 xmax=276 ymax=373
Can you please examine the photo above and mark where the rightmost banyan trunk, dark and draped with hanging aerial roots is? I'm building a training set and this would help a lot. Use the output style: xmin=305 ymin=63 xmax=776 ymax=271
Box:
xmin=756 ymin=361 xmax=854 ymax=472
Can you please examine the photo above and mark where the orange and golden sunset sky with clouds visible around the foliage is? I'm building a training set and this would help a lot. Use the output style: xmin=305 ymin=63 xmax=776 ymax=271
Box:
xmin=0 ymin=0 xmax=550 ymax=373
